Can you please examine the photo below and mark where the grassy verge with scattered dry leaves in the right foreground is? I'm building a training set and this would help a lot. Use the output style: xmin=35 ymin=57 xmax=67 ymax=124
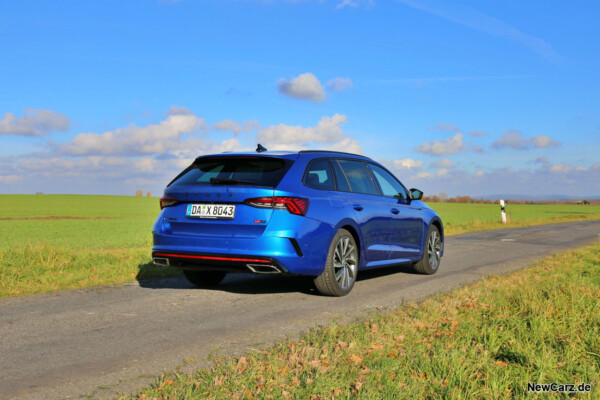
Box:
xmin=123 ymin=243 xmax=600 ymax=399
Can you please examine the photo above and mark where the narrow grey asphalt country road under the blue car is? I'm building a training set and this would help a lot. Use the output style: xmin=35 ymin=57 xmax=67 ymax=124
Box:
xmin=0 ymin=221 xmax=600 ymax=399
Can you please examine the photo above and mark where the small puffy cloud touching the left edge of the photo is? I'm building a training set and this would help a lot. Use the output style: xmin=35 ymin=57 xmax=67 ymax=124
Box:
xmin=0 ymin=108 xmax=71 ymax=136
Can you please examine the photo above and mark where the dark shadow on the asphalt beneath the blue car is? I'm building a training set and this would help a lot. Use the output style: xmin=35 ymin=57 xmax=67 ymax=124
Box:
xmin=137 ymin=263 xmax=414 ymax=296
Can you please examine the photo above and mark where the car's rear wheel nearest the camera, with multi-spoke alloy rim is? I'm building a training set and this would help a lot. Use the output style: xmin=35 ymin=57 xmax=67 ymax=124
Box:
xmin=314 ymin=229 xmax=358 ymax=297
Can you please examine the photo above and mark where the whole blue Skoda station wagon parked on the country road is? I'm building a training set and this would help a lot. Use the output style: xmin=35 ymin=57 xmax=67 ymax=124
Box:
xmin=152 ymin=145 xmax=444 ymax=296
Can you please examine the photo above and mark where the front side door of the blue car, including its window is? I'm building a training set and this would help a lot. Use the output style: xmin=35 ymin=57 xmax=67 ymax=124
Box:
xmin=368 ymin=163 xmax=423 ymax=262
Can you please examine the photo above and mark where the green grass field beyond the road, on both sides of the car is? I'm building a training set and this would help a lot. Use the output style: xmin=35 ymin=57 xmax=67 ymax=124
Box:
xmin=0 ymin=195 xmax=600 ymax=297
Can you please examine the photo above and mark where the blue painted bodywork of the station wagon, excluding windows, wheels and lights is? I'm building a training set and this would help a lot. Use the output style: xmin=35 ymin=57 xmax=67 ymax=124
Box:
xmin=152 ymin=152 xmax=444 ymax=276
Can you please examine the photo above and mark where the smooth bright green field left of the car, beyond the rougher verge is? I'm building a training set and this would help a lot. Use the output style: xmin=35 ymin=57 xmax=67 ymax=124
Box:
xmin=0 ymin=195 xmax=159 ymax=249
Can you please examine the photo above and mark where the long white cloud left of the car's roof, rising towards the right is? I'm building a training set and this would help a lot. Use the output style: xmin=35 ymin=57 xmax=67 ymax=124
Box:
xmin=58 ymin=115 xmax=206 ymax=156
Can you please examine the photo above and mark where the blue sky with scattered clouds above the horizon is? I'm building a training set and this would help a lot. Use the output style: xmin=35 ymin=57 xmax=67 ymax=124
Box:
xmin=0 ymin=0 xmax=600 ymax=198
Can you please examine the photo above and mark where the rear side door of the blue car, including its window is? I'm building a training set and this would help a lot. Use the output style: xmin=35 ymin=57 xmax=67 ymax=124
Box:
xmin=333 ymin=159 xmax=391 ymax=267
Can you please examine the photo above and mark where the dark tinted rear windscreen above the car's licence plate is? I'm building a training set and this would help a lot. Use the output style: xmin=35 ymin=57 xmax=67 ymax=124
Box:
xmin=169 ymin=157 xmax=293 ymax=188
